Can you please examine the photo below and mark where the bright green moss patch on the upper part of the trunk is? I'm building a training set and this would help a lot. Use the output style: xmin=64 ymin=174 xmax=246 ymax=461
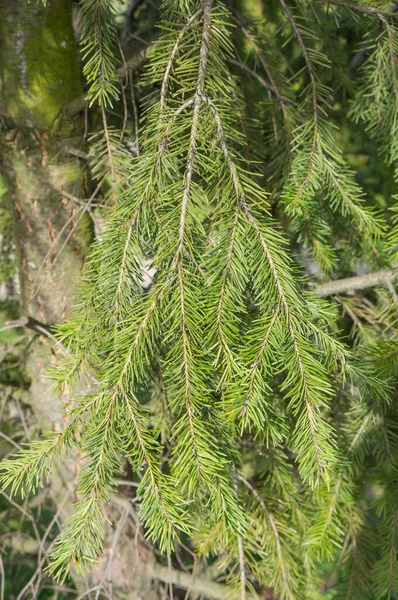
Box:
xmin=0 ymin=0 xmax=82 ymax=129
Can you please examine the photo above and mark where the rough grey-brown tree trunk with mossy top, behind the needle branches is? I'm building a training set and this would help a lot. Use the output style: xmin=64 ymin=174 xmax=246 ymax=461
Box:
xmin=0 ymin=0 xmax=162 ymax=600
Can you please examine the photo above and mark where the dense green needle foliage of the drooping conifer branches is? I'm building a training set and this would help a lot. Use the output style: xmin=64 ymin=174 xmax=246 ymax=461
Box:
xmin=2 ymin=0 xmax=398 ymax=600
